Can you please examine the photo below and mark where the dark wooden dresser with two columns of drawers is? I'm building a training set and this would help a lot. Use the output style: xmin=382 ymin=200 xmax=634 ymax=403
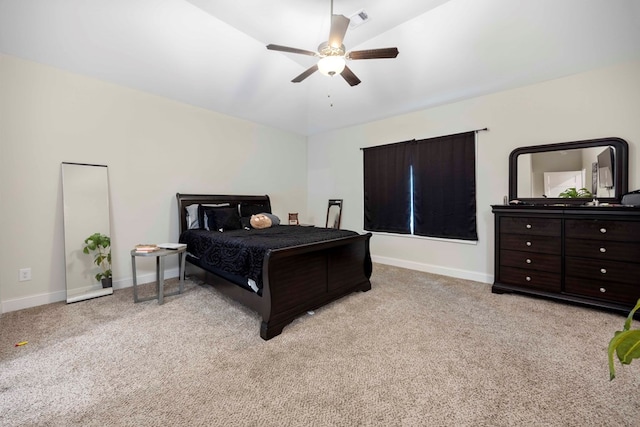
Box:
xmin=492 ymin=205 xmax=640 ymax=314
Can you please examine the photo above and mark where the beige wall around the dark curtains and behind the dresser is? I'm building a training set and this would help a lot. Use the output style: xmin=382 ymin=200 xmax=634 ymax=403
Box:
xmin=308 ymin=57 xmax=640 ymax=283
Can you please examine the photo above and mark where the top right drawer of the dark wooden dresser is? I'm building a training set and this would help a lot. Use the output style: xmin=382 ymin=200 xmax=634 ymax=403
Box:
xmin=564 ymin=219 xmax=640 ymax=242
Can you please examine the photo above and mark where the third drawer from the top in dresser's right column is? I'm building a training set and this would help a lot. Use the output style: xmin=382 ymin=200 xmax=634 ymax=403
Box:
xmin=565 ymin=257 xmax=640 ymax=285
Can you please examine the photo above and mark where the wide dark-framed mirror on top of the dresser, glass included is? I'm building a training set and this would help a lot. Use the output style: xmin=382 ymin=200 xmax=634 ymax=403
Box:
xmin=509 ymin=137 xmax=629 ymax=205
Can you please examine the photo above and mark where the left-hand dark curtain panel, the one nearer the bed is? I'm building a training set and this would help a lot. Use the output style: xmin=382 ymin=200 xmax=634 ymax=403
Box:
xmin=363 ymin=141 xmax=414 ymax=234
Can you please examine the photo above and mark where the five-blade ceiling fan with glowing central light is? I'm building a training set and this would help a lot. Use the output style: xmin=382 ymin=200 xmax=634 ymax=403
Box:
xmin=267 ymin=0 xmax=398 ymax=86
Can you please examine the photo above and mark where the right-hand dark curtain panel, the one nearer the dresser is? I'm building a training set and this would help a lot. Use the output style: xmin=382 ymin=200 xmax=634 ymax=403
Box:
xmin=413 ymin=132 xmax=478 ymax=240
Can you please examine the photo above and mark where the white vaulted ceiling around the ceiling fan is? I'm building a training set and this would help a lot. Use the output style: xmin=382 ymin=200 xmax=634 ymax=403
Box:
xmin=0 ymin=0 xmax=640 ymax=135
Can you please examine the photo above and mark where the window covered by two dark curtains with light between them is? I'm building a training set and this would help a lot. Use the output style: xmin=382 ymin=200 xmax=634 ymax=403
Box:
xmin=363 ymin=132 xmax=478 ymax=240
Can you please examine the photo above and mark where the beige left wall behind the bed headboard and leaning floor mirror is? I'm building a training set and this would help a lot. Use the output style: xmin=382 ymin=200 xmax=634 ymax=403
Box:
xmin=0 ymin=55 xmax=307 ymax=312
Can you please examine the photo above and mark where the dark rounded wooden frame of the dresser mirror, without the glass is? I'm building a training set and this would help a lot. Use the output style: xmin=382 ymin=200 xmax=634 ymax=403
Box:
xmin=509 ymin=137 xmax=629 ymax=205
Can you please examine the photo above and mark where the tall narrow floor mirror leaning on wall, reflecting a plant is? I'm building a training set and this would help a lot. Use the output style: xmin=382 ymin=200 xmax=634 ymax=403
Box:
xmin=61 ymin=162 xmax=113 ymax=303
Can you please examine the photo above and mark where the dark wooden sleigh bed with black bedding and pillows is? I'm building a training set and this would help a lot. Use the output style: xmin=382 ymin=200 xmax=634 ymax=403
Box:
xmin=176 ymin=193 xmax=372 ymax=340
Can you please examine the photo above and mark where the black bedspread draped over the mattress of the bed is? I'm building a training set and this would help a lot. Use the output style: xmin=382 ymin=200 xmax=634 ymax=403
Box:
xmin=180 ymin=225 xmax=358 ymax=289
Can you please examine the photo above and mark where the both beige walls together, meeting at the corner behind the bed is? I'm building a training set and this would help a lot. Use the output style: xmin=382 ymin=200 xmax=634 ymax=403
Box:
xmin=0 ymin=56 xmax=640 ymax=311
